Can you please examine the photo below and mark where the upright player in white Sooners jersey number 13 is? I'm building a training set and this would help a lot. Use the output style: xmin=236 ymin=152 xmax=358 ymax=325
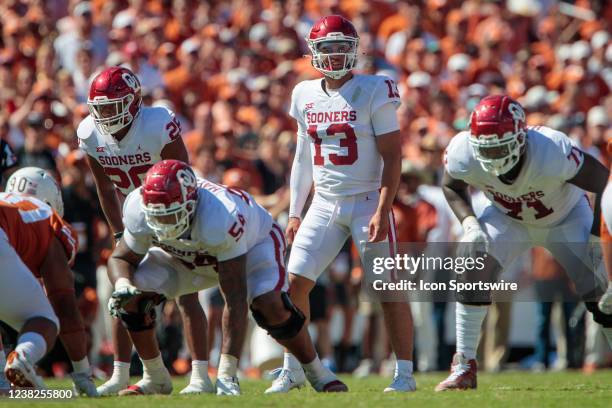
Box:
xmin=266 ymin=15 xmax=416 ymax=393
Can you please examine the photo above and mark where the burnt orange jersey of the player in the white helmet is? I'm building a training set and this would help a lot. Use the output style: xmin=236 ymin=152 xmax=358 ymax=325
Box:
xmin=0 ymin=193 xmax=78 ymax=277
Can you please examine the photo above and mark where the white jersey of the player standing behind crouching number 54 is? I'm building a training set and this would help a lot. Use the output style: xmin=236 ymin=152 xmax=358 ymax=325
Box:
xmin=77 ymin=106 xmax=181 ymax=196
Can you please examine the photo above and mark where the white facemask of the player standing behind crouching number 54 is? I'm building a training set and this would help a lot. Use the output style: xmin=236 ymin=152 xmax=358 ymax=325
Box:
xmin=87 ymin=94 xmax=134 ymax=135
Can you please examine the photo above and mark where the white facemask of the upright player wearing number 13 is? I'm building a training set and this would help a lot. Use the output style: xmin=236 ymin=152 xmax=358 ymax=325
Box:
xmin=307 ymin=37 xmax=359 ymax=79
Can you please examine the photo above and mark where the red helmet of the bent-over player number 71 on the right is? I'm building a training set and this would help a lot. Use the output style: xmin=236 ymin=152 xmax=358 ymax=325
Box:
xmin=470 ymin=95 xmax=527 ymax=176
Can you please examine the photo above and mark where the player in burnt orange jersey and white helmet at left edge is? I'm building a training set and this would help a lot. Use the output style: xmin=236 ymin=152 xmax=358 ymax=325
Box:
xmin=0 ymin=167 xmax=98 ymax=397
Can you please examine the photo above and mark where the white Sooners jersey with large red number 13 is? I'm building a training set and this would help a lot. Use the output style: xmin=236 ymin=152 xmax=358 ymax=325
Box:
xmin=289 ymin=75 xmax=400 ymax=196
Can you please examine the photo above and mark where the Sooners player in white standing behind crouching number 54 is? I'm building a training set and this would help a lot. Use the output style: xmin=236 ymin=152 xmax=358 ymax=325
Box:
xmin=77 ymin=67 xmax=212 ymax=395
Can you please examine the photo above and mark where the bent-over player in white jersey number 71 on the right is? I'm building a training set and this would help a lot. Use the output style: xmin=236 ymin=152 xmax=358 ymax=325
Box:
xmin=436 ymin=95 xmax=612 ymax=391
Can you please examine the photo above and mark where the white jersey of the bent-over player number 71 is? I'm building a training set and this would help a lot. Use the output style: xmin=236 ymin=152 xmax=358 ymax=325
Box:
xmin=445 ymin=126 xmax=585 ymax=227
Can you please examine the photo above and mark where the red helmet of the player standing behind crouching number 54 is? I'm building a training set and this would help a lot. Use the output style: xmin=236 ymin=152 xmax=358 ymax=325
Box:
xmin=87 ymin=67 xmax=142 ymax=135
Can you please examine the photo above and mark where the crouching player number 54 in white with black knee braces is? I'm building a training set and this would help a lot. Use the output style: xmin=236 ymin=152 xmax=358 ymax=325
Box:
xmin=109 ymin=160 xmax=346 ymax=395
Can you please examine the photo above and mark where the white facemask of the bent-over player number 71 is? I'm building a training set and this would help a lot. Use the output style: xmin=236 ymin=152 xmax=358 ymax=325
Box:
xmin=470 ymin=130 xmax=527 ymax=176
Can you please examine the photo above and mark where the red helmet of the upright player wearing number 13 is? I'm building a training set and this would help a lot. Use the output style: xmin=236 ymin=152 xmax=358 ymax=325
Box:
xmin=306 ymin=15 xmax=359 ymax=79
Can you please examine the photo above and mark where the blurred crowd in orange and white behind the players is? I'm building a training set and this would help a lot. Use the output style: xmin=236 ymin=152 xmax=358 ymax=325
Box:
xmin=0 ymin=0 xmax=612 ymax=380
